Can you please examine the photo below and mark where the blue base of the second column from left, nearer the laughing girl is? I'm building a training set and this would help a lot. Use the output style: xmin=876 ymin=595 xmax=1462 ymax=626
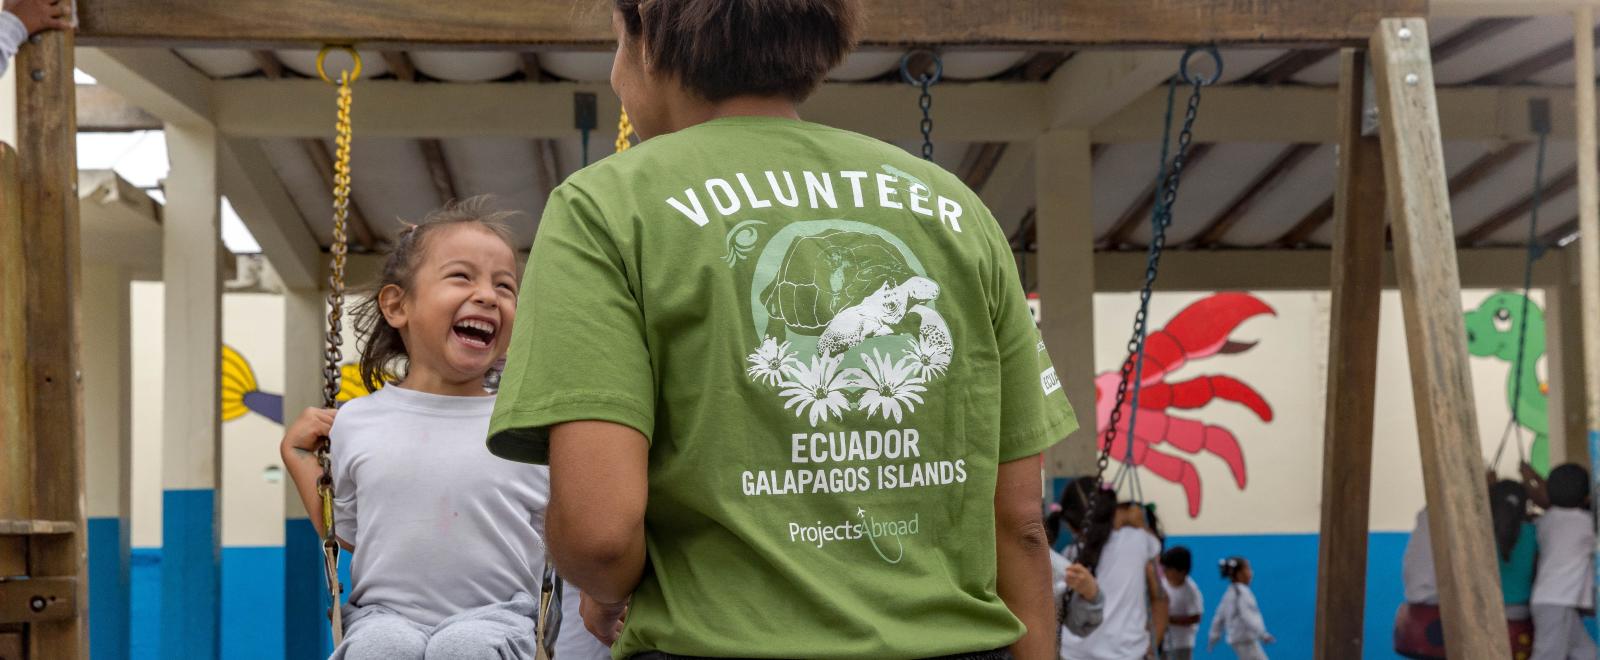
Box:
xmin=160 ymin=489 xmax=221 ymax=660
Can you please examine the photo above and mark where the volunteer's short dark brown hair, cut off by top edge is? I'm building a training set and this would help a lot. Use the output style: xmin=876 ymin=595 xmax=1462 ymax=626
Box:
xmin=616 ymin=0 xmax=861 ymax=101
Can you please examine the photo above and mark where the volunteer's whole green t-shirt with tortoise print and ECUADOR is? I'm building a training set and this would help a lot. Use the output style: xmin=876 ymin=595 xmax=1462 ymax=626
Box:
xmin=488 ymin=117 xmax=1077 ymax=658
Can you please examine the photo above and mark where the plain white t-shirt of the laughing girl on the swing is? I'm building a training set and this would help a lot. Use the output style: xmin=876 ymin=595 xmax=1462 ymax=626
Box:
xmin=330 ymin=384 xmax=550 ymax=626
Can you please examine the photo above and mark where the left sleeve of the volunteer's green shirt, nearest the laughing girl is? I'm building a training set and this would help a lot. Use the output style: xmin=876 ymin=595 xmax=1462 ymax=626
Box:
xmin=488 ymin=184 xmax=656 ymax=463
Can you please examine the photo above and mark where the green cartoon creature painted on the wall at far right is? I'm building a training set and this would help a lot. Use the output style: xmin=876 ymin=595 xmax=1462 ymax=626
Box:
xmin=1466 ymin=292 xmax=1550 ymax=474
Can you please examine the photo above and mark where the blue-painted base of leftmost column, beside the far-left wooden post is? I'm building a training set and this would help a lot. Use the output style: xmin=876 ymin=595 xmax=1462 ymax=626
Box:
xmin=88 ymin=517 xmax=130 ymax=660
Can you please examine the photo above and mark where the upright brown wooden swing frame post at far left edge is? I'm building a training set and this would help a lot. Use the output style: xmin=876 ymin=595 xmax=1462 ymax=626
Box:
xmin=0 ymin=23 xmax=88 ymax=658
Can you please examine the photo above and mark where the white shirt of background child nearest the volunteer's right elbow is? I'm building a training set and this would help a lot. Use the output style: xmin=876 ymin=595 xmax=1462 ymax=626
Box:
xmin=1061 ymin=527 xmax=1162 ymax=660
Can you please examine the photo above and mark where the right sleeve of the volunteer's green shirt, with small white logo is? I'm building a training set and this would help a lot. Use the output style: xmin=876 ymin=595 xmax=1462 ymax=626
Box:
xmin=990 ymin=211 xmax=1088 ymax=463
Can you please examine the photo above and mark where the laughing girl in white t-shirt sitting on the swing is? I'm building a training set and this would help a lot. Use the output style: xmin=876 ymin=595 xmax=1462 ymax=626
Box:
xmin=282 ymin=199 xmax=549 ymax=660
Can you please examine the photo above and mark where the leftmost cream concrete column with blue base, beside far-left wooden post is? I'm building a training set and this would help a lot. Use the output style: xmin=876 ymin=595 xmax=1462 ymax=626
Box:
xmin=80 ymin=261 xmax=133 ymax=660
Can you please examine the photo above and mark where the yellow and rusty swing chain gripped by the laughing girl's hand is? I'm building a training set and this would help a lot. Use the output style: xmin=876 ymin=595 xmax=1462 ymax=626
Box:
xmin=315 ymin=46 xmax=362 ymax=647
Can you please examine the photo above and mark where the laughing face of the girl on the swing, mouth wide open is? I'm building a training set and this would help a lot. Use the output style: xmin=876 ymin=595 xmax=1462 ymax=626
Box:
xmin=384 ymin=224 xmax=517 ymax=384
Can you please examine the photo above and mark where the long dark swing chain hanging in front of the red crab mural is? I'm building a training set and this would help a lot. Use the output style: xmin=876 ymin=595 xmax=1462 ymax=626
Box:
xmin=1078 ymin=46 xmax=1222 ymax=556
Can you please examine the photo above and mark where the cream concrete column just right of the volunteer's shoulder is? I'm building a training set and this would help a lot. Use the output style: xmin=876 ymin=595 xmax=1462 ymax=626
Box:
xmin=1034 ymin=130 xmax=1096 ymax=477
